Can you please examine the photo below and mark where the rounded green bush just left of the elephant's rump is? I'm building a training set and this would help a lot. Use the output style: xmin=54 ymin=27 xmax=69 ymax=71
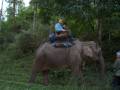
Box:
xmin=7 ymin=25 xmax=48 ymax=58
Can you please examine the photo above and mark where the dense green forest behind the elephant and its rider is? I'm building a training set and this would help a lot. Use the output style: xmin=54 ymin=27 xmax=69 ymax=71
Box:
xmin=0 ymin=0 xmax=120 ymax=90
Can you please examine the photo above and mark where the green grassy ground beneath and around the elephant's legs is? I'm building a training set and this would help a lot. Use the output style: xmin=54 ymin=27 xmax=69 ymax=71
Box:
xmin=0 ymin=53 xmax=111 ymax=90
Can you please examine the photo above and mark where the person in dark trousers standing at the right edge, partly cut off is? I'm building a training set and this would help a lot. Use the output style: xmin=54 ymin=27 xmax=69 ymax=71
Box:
xmin=112 ymin=51 xmax=120 ymax=90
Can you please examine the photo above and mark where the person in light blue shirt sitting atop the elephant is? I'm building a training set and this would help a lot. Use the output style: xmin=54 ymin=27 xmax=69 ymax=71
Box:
xmin=55 ymin=18 xmax=73 ymax=46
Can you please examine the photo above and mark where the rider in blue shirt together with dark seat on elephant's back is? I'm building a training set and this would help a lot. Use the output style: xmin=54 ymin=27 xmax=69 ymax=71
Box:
xmin=49 ymin=17 xmax=74 ymax=47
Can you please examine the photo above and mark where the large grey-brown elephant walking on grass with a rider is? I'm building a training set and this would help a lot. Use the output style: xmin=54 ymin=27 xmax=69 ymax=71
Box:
xmin=29 ymin=40 xmax=105 ymax=85
